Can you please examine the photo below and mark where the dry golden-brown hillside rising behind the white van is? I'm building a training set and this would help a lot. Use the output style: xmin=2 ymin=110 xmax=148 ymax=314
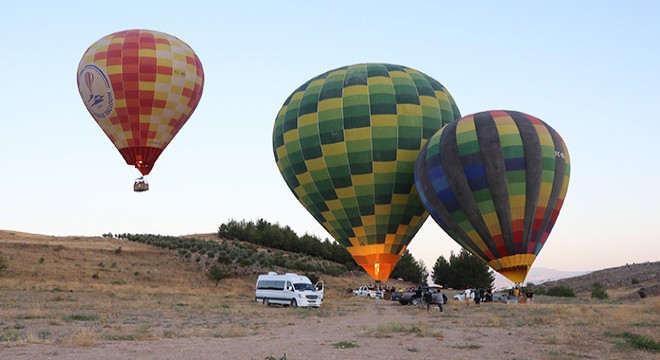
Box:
xmin=0 ymin=230 xmax=400 ymax=297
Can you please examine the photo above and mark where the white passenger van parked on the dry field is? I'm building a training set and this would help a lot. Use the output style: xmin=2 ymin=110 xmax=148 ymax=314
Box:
xmin=254 ymin=271 xmax=323 ymax=308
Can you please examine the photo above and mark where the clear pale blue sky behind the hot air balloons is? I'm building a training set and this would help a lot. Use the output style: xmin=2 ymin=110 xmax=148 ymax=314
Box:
xmin=0 ymin=0 xmax=660 ymax=271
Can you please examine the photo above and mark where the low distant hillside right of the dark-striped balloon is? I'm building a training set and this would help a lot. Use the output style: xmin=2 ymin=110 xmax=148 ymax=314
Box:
xmin=539 ymin=261 xmax=660 ymax=299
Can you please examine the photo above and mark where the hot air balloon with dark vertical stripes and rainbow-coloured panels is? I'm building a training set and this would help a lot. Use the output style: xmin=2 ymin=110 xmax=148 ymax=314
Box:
xmin=415 ymin=111 xmax=570 ymax=283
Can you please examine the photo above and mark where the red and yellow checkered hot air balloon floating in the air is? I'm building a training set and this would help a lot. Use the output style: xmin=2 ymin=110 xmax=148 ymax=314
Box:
xmin=78 ymin=30 xmax=204 ymax=191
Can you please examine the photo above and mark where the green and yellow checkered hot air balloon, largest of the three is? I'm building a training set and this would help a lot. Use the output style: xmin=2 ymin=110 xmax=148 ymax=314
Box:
xmin=273 ymin=63 xmax=460 ymax=281
